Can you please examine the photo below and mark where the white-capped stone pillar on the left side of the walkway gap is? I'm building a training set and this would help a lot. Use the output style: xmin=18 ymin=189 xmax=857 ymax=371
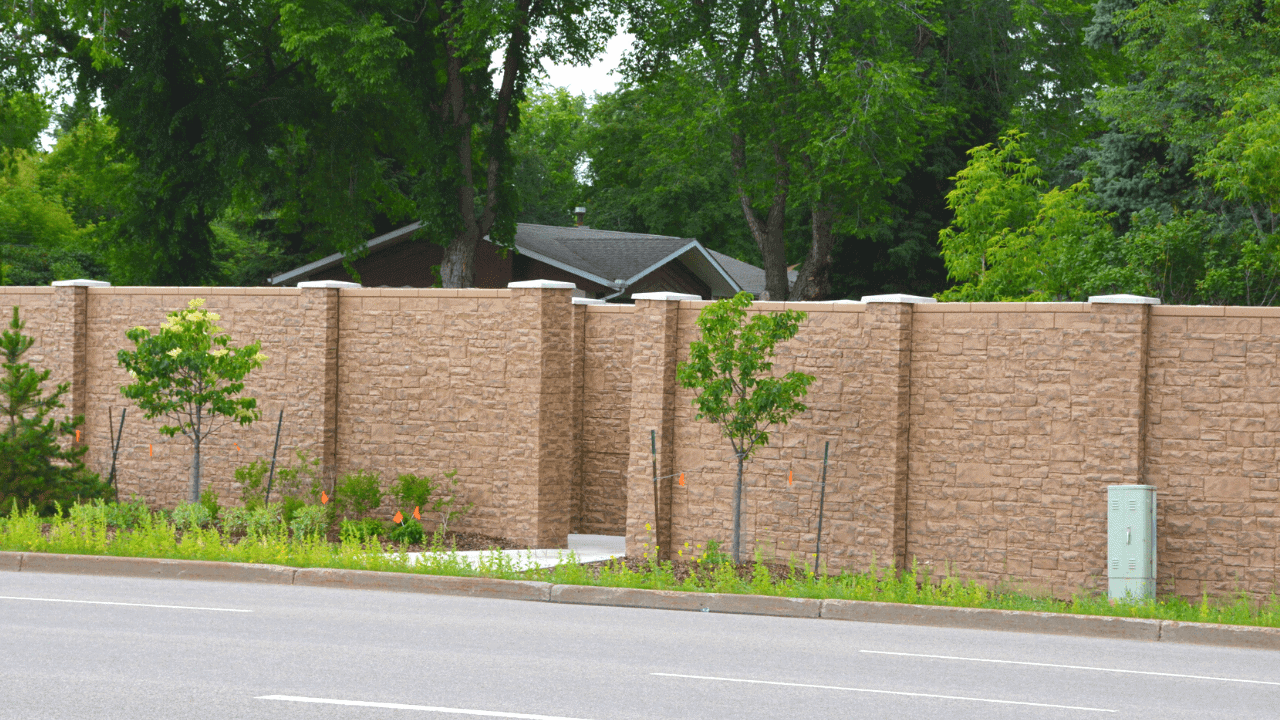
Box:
xmin=507 ymin=281 xmax=575 ymax=547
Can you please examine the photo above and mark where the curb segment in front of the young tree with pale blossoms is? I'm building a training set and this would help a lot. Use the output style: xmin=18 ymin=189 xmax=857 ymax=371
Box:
xmin=22 ymin=552 xmax=297 ymax=585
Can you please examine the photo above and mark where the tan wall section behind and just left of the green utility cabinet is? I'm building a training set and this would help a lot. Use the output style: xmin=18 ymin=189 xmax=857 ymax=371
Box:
xmin=908 ymin=302 xmax=1148 ymax=594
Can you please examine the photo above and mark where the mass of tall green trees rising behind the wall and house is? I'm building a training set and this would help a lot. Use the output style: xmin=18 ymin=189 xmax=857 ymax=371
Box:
xmin=0 ymin=0 xmax=1280 ymax=305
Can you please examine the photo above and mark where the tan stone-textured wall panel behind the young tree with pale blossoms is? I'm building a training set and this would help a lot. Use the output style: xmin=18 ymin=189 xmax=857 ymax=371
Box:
xmin=80 ymin=287 xmax=335 ymax=507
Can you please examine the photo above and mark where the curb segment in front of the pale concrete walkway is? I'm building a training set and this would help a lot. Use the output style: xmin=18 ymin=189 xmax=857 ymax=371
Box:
xmin=293 ymin=568 xmax=552 ymax=602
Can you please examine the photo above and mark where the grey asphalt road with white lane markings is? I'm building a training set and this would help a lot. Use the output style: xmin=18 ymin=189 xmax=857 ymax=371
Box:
xmin=0 ymin=573 xmax=1280 ymax=720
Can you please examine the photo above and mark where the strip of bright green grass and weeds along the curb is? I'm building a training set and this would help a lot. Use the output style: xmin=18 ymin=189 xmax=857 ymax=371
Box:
xmin=0 ymin=499 xmax=1280 ymax=628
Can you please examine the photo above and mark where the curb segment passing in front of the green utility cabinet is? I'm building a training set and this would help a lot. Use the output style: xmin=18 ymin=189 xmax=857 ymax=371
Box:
xmin=822 ymin=600 xmax=1161 ymax=642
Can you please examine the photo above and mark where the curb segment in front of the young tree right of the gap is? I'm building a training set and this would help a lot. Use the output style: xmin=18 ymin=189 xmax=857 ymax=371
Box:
xmin=550 ymin=585 xmax=822 ymax=618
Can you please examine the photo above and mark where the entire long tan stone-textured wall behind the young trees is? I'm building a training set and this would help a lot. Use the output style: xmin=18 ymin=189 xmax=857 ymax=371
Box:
xmin=0 ymin=283 xmax=1280 ymax=596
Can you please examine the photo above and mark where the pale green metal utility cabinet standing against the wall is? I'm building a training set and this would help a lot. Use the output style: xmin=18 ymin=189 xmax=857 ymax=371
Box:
xmin=1107 ymin=486 xmax=1156 ymax=600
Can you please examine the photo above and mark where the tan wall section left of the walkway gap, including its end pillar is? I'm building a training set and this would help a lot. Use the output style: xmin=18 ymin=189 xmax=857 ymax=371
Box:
xmin=337 ymin=288 xmax=570 ymax=543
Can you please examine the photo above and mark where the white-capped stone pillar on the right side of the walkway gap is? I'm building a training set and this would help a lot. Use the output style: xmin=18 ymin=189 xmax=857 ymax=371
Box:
xmin=627 ymin=292 xmax=701 ymax=556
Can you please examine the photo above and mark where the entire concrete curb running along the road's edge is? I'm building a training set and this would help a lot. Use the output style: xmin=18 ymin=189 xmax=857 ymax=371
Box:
xmin=10 ymin=552 xmax=1280 ymax=651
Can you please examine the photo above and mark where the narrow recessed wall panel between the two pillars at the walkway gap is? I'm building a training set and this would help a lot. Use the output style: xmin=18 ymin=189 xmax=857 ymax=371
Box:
xmin=573 ymin=305 xmax=635 ymax=536
